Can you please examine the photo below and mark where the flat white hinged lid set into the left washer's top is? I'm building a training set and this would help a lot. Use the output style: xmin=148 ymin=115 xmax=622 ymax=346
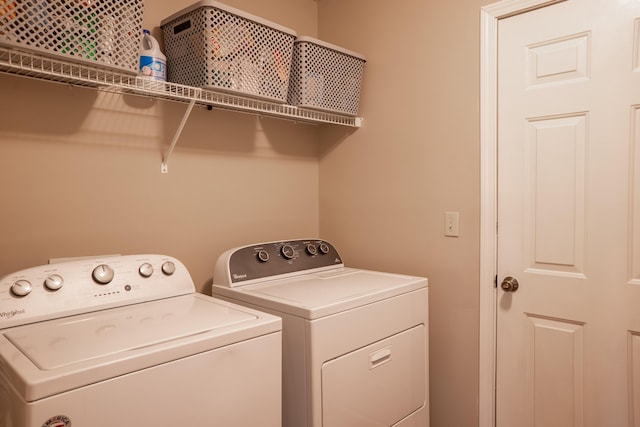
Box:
xmin=5 ymin=298 xmax=256 ymax=370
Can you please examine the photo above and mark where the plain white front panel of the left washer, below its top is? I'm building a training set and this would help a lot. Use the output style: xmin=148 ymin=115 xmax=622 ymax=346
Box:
xmin=0 ymin=331 xmax=282 ymax=427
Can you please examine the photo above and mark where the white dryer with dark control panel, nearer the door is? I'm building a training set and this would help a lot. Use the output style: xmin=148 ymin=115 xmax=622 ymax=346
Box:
xmin=213 ymin=239 xmax=429 ymax=427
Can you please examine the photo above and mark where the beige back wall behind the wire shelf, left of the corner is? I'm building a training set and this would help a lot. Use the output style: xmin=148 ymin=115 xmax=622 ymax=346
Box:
xmin=0 ymin=0 xmax=319 ymax=293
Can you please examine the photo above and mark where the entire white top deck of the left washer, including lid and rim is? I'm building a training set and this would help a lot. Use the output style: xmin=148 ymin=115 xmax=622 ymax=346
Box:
xmin=0 ymin=293 xmax=282 ymax=402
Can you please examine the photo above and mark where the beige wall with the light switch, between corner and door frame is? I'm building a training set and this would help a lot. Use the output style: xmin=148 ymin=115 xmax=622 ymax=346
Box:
xmin=318 ymin=0 xmax=490 ymax=427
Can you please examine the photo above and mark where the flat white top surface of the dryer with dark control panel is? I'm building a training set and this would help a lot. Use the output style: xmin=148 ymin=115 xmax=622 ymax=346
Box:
xmin=213 ymin=267 xmax=427 ymax=319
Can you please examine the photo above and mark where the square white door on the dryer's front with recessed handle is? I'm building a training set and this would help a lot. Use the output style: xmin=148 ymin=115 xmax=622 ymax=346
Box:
xmin=322 ymin=325 xmax=427 ymax=427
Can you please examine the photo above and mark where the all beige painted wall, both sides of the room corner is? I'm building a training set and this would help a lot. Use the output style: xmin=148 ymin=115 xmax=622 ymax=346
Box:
xmin=0 ymin=0 xmax=490 ymax=427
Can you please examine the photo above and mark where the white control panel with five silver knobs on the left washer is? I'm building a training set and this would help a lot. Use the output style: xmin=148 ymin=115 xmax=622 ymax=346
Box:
xmin=0 ymin=255 xmax=195 ymax=329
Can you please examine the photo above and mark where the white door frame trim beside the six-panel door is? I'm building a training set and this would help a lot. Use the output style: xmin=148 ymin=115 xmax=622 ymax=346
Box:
xmin=478 ymin=0 xmax=566 ymax=427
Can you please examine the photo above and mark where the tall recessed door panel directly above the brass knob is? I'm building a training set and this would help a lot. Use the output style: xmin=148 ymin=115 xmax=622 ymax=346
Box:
xmin=525 ymin=114 xmax=587 ymax=274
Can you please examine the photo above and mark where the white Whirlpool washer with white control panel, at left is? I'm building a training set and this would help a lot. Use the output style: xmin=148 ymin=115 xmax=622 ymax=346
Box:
xmin=0 ymin=255 xmax=282 ymax=427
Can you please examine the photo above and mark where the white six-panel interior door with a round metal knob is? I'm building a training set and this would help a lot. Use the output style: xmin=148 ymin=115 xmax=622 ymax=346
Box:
xmin=496 ymin=0 xmax=640 ymax=427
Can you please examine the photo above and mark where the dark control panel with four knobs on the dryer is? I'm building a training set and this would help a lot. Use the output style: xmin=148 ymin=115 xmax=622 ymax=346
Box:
xmin=213 ymin=239 xmax=344 ymax=287
